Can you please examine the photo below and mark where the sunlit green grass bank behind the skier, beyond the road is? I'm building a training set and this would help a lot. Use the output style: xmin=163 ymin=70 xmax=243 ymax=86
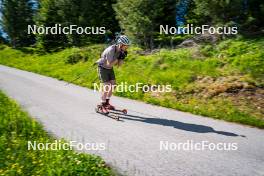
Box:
xmin=0 ymin=38 xmax=264 ymax=128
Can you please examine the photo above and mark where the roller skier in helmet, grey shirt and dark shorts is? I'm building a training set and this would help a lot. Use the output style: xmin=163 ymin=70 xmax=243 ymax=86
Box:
xmin=95 ymin=34 xmax=130 ymax=120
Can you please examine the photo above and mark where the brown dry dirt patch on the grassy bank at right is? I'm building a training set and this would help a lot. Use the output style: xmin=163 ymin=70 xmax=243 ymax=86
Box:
xmin=189 ymin=76 xmax=264 ymax=119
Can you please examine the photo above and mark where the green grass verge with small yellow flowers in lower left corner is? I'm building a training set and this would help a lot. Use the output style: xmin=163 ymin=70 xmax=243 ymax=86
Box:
xmin=0 ymin=92 xmax=113 ymax=176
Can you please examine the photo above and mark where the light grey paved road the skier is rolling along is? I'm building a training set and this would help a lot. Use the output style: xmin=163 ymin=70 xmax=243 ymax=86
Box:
xmin=0 ymin=66 xmax=264 ymax=176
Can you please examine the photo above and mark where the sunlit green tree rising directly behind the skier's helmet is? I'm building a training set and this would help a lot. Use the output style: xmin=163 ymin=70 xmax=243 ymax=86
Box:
xmin=114 ymin=0 xmax=172 ymax=49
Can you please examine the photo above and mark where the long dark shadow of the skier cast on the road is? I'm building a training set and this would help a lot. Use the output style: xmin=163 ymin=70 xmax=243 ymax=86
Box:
xmin=112 ymin=112 xmax=245 ymax=137
